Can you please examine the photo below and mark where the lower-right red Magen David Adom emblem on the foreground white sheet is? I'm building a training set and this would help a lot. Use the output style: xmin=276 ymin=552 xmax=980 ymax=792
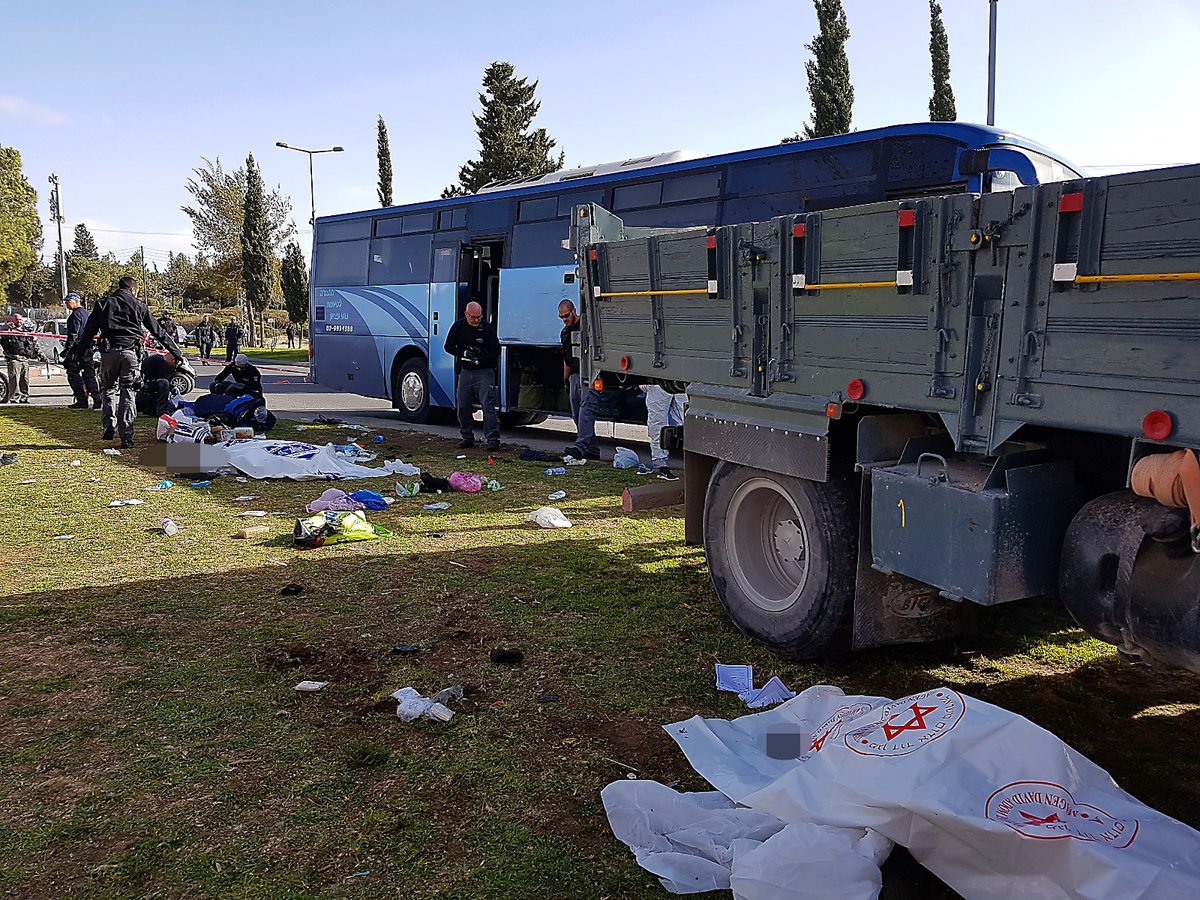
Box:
xmin=984 ymin=781 xmax=1140 ymax=850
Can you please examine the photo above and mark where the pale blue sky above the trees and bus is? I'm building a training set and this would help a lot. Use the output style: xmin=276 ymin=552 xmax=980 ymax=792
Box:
xmin=0 ymin=0 xmax=1200 ymax=270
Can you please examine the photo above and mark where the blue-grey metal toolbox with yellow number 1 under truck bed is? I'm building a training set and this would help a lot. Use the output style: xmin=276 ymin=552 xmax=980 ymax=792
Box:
xmin=869 ymin=439 xmax=1084 ymax=606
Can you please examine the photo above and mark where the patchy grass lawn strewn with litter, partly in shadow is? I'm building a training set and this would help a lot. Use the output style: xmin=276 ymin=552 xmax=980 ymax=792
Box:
xmin=0 ymin=409 xmax=1200 ymax=899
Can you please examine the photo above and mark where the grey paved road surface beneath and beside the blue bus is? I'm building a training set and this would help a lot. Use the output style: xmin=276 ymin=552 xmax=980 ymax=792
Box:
xmin=16 ymin=358 xmax=667 ymax=466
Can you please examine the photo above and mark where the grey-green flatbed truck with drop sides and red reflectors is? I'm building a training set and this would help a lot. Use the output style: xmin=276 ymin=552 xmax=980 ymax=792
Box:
xmin=571 ymin=167 xmax=1200 ymax=671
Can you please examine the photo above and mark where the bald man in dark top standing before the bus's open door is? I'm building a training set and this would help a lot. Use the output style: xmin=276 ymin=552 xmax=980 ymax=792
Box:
xmin=445 ymin=300 xmax=500 ymax=450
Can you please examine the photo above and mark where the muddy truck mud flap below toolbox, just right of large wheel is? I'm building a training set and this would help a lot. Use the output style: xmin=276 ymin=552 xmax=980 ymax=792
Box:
xmin=853 ymin=473 xmax=978 ymax=650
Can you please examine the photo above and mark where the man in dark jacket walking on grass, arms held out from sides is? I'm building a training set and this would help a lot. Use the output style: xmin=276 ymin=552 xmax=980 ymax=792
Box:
xmin=74 ymin=275 xmax=184 ymax=448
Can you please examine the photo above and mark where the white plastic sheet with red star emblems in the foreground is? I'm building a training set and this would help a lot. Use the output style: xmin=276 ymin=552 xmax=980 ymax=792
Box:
xmin=604 ymin=685 xmax=1200 ymax=900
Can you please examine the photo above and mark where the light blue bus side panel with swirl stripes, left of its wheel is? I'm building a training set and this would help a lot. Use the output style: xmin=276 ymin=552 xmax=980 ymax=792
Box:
xmin=313 ymin=284 xmax=430 ymax=397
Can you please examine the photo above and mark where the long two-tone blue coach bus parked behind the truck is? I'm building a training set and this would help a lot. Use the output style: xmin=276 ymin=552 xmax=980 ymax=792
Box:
xmin=310 ymin=122 xmax=1080 ymax=427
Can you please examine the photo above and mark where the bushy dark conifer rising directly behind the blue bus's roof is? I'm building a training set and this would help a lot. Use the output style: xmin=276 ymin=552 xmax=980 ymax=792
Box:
xmin=442 ymin=61 xmax=563 ymax=197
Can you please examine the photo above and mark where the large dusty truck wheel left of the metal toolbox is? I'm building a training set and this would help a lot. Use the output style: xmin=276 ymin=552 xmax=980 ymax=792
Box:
xmin=704 ymin=462 xmax=858 ymax=659
